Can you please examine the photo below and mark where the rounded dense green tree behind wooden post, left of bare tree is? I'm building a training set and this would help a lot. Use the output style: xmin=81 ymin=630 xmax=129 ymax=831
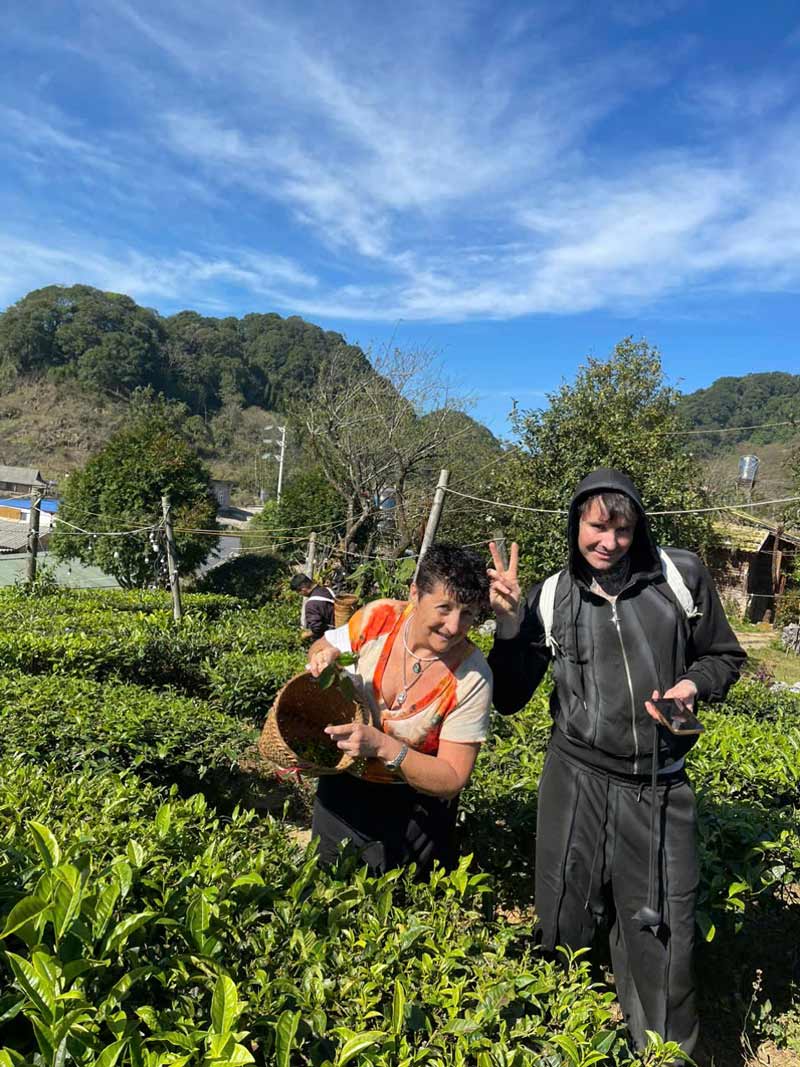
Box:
xmin=50 ymin=401 xmax=218 ymax=588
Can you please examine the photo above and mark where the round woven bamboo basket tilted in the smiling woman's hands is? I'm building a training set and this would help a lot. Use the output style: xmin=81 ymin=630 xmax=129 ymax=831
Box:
xmin=258 ymin=671 xmax=369 ymax=778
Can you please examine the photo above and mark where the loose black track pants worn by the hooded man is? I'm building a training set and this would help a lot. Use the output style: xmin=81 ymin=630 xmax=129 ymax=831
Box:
xmin=535 ymin=749 xmax=698 ymax=1053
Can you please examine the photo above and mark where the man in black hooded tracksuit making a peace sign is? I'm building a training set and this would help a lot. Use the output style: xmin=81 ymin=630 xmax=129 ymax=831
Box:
xmin=489 ymin=469 xmax=745 ymax=1053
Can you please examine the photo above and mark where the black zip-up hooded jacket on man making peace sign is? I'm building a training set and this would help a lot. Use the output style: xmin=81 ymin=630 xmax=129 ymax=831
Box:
xmin=489 ymin=468 xmax=746 ymax=775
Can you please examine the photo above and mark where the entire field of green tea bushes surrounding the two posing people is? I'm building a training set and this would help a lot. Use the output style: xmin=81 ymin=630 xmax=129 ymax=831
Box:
xmin=0 ymin=591 xmax=800 ymax=1067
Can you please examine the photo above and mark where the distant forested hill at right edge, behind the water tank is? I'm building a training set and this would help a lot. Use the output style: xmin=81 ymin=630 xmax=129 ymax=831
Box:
xmin=681 ymin=370 xmax=800 ymax=455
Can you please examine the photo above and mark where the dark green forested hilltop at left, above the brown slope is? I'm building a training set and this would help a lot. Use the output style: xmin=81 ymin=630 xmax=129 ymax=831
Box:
xmin=0 ymin=285 xmax=371 ymax=416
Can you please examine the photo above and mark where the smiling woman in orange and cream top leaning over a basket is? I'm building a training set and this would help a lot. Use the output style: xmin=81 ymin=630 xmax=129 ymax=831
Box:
xmin=308 ymin=544 xmax=492 ymax=875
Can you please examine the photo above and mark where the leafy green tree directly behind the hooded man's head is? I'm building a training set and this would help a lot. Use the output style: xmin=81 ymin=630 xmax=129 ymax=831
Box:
xmin=493 ymin=337 xmax=714 ymax=578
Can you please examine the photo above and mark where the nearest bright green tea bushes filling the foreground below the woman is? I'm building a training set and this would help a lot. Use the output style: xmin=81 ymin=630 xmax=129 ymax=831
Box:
xmin=0 ymin=761 xmax=691 ymax=1067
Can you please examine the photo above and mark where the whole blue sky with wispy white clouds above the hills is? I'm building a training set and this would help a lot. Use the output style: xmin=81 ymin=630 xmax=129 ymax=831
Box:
xmin=0 ymin=0 xmax=800 ymax=431
